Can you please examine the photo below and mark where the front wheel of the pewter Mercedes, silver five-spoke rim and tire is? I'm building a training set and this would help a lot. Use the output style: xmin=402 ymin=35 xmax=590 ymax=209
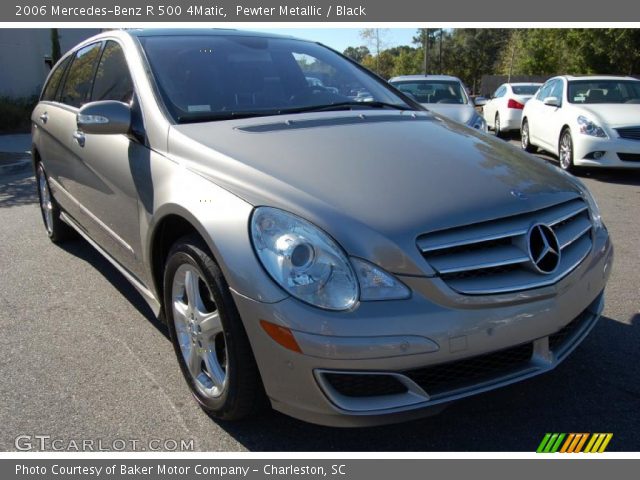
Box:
xmin=164 ymin=235 xmax=266 ymax=420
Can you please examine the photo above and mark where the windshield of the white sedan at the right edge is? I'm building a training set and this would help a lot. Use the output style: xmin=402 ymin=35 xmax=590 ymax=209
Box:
xmin=567 ymin=80 xmax=640 ymax=104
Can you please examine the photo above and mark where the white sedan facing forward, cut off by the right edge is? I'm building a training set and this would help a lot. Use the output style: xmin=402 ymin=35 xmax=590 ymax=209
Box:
xmin=521 ymin=76 xmax=640 ymax=170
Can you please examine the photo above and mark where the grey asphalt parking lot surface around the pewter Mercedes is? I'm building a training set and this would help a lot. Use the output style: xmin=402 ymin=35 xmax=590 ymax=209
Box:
xmin=0 ymin=140 xmax=640 ymax=451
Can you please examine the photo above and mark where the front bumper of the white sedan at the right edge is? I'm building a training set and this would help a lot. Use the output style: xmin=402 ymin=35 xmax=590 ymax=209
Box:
xmin=573 ymin=134 xmax=640 ymax=168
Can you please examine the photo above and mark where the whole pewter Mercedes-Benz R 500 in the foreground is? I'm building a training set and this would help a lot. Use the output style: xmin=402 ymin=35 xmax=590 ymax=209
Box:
xmin=32 ymin=30 xmax=612 ymax=426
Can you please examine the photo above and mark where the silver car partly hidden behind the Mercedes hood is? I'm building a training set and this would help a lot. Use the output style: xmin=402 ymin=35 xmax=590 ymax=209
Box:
xmin=389 ymin=75 xmax=487 ymax=132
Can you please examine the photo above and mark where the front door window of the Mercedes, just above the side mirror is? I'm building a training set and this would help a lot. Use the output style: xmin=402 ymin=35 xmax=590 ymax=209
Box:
xmin=91 ymin=41 xmax=133 ymax=103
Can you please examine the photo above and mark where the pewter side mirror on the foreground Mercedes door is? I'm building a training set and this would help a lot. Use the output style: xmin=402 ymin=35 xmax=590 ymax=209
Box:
xmin=76 ymin=100 xmax=131 ymax=135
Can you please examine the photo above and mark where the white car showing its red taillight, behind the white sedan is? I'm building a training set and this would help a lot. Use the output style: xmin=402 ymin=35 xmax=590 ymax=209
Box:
xmin=482 ymin=83 xmax=542 ymax=137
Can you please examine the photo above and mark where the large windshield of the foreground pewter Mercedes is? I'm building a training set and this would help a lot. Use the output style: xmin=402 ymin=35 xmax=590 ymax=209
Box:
xmin=139 ymin=35 xmax=412 ymax=122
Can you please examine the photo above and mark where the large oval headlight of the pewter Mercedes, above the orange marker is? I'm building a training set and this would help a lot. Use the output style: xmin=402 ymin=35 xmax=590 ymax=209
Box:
xmin=251 ymin=207 xmax=359 ymax=310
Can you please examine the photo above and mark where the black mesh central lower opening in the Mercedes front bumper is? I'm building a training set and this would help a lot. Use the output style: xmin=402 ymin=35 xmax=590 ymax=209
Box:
xmin=403 ymin=343 xmax=533 ymax=399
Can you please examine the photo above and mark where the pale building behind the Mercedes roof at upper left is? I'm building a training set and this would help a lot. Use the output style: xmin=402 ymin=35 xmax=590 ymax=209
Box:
xmin=0 ymin=28 xmax=101 ymax=98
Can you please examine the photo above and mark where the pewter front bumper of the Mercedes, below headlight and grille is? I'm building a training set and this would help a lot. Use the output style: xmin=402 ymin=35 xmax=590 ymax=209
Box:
xmin=234 ymin=230 xmax=613 ymax=426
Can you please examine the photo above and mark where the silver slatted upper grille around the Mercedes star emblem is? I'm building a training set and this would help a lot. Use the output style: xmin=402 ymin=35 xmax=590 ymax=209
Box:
xmin=418 ymin=198 xmax=592 ymax=295
